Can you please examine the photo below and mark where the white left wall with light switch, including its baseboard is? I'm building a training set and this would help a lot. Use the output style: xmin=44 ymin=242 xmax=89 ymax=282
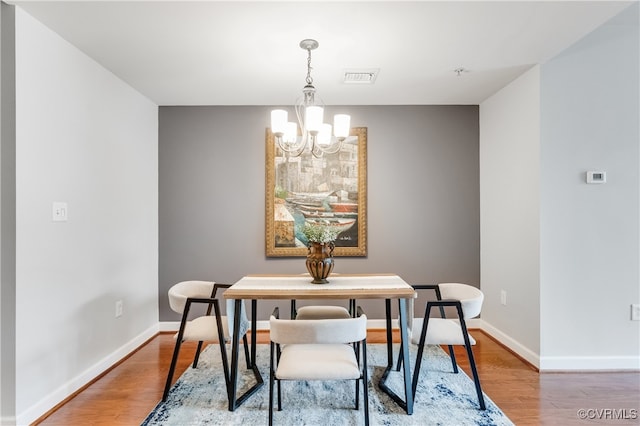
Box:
xmin=16 ymin=8 xmax=158 ymax=424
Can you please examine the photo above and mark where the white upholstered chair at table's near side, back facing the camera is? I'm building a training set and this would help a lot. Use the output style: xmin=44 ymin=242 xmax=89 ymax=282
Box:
xmin=269 ymin=307 xmax=369 ymax=425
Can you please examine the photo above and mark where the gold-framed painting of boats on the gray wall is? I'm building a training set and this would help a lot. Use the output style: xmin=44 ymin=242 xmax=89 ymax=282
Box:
xmin=265 ymin=127 xmax=367 ymax=257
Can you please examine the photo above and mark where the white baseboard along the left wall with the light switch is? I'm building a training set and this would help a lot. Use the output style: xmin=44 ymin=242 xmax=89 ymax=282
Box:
xmin=16 ymin=324 xmax=159 ymax=426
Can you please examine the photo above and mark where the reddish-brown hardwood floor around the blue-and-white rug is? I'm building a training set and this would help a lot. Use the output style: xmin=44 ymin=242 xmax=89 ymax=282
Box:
xmin=34 ymin=330 xmax=640 ymax=426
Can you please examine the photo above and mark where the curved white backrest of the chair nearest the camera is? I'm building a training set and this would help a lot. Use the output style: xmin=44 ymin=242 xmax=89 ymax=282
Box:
xmin=269 ymin=315 xmax=367 ymax=344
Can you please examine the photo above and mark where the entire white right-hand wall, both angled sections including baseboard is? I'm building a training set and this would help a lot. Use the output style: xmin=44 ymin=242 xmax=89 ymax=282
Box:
xmin=480 ymin=3 xmax=640 ymax=370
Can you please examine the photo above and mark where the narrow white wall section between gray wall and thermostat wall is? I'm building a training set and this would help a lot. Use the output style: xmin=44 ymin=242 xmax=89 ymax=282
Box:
xmin=480 ymin=66 xmax=540 ymax=365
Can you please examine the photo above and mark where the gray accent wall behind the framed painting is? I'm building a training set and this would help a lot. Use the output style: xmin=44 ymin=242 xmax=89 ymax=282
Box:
xmin=158 ymin=106 xmax=480 ymax=321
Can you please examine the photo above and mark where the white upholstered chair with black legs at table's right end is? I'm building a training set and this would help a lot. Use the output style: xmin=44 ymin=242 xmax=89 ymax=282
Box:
xmin=397 ymin=283 xmax=486 ymax=410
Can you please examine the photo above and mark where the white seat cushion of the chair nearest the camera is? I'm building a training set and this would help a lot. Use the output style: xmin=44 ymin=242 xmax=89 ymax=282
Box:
xmin=276 ymin=343 xmax=360 ymax=380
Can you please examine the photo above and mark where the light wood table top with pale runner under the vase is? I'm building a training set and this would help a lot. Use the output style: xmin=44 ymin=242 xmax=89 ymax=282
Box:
xmin=224 ymin=274 xmax=416 ymax=299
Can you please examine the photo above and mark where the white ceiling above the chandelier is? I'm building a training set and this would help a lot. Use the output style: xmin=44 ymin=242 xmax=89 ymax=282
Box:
xmin=10 ymin=0 xmax=637 ymax=105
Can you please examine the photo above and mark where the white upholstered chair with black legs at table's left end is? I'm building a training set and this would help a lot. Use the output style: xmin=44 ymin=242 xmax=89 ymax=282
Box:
xmin=162 ymin=281 xmax=251 ymax=401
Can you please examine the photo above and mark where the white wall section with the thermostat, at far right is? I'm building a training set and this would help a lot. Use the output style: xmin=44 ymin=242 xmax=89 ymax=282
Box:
xmin=540 ymin=3 xmax=640 ymax=369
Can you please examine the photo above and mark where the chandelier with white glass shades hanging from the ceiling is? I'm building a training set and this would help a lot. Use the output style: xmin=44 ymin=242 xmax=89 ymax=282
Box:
xmin=271 ymin=39 xmax=351 ymax=157
